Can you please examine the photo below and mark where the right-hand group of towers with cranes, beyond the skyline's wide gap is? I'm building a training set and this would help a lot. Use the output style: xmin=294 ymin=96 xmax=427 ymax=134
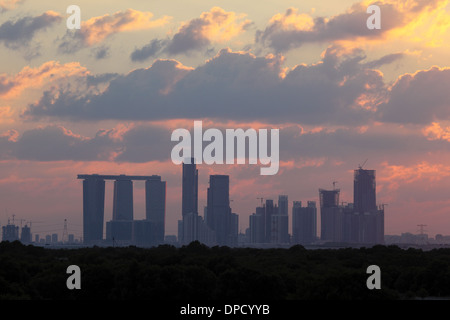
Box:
xmin=248 ymin=168 xmax=384 ymax=245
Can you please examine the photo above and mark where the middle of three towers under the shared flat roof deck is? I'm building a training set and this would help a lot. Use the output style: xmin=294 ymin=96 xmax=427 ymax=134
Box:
xmin=113 ymin=179 xmax=133 ymax=221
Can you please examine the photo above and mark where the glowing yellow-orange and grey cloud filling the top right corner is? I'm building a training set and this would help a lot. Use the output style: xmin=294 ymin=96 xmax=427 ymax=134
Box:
xmin=256 ymin=0 xmax=450 ymax=51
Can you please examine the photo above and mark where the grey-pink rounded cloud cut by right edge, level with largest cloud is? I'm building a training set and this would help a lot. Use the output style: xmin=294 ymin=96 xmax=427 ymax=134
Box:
xmin=379 ymin=67 xmax=450 ymax=125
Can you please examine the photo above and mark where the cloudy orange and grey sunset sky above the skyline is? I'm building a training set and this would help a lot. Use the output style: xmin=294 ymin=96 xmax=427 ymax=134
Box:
xmin=0 ymin=0 xmax=450 ymax=237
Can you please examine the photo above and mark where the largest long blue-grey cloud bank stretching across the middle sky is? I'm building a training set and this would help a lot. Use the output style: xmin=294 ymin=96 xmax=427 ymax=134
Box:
xmin=24 ymin=48 xmax=386 ymax=125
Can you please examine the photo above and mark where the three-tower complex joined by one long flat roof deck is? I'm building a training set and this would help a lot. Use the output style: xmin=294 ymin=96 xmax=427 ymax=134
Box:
xmin=78 ymin=174 xmax=166 ymax=246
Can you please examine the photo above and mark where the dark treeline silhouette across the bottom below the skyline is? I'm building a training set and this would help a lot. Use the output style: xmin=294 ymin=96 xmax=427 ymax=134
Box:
xmin=0 ymin=241 xmax=450 ymax=301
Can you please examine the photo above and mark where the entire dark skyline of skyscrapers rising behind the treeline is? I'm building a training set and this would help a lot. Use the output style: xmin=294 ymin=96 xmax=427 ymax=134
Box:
xmin=76 ymin=164 xmax=384 ymax=246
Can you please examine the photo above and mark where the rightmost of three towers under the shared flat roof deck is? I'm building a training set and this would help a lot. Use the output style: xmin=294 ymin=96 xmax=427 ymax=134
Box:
xmin=145 ymin=176 xmax=166 ymax=244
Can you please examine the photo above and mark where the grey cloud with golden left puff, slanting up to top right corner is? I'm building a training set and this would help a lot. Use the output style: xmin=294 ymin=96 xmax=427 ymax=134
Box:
xmin=256 ymin=0 xmax=448 ymax=52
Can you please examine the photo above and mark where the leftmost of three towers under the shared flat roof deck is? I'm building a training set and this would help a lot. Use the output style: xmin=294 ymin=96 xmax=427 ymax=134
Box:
xmin=83 ymin=175 xmax=105 ymax=243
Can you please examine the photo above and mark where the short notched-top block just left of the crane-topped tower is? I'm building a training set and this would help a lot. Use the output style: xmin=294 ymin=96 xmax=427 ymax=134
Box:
xmin=292 ymin=201 xmax=317 ymax=245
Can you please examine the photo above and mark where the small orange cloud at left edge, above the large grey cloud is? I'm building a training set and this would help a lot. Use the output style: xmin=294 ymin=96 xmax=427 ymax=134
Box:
xmin=0 ymin=61 xmax=89 ymax=99
